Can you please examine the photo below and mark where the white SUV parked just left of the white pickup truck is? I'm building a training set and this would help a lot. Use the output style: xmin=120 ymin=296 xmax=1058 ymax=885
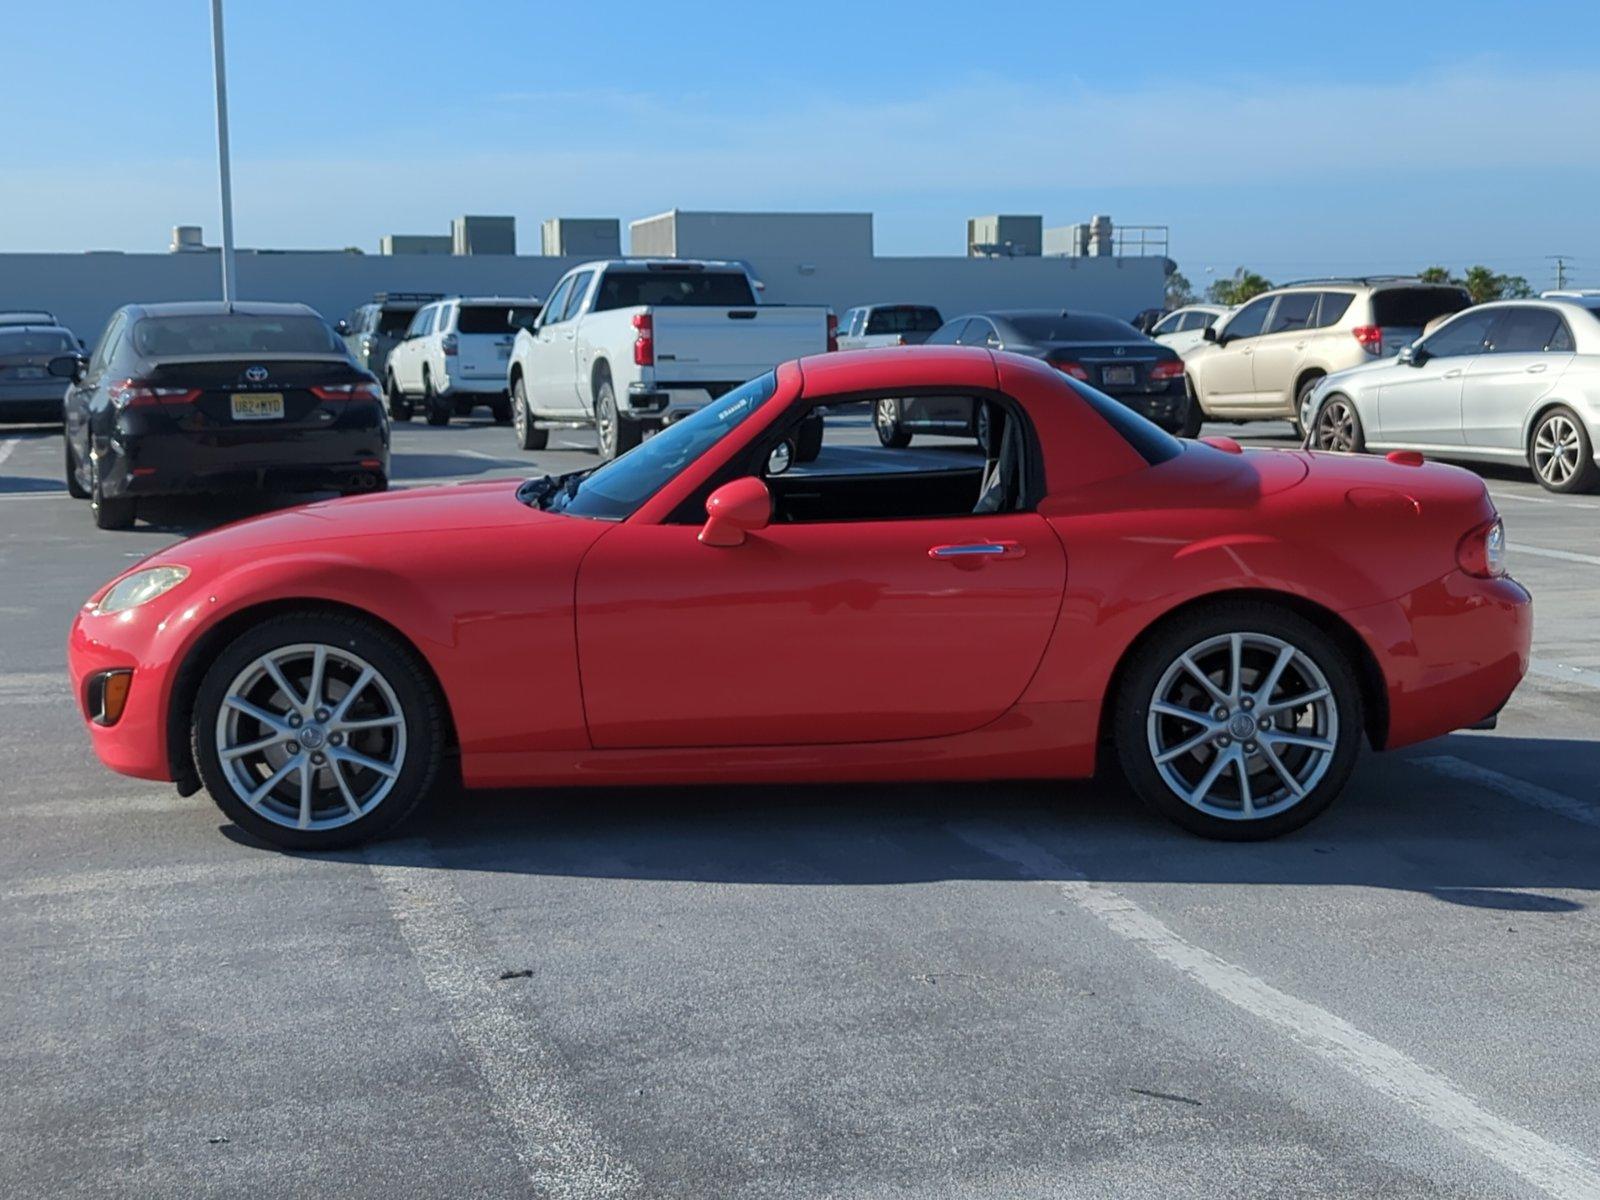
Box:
xmin=384 ymin=296 xmax=539 ymax=426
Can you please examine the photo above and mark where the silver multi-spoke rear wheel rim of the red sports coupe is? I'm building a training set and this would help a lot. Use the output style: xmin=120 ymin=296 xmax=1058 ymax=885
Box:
xmin=1146 ymin=632 xmax=1339 ymax=821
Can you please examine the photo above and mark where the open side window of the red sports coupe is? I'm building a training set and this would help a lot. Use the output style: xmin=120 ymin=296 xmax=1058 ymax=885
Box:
xmin=752 ymin=394 xmax=1037 ymax=525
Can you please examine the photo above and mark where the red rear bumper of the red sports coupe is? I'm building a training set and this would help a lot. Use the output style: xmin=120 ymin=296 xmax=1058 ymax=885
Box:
xmin=1344 ymin=571 xmax=1533 ymax=749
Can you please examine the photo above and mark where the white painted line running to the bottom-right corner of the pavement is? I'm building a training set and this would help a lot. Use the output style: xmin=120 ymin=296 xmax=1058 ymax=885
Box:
xmin=950 ymin=822 xmax=1600 ymax=1200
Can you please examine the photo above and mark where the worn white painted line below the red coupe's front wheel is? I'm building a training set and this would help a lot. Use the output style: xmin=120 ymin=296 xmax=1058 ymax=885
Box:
xmin=366 ymin=840 xmax=640 ymax=1200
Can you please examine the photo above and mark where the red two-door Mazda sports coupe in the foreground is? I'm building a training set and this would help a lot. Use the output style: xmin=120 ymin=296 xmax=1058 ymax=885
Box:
xmin=70 ymin=347 xmax=1531 ymax=848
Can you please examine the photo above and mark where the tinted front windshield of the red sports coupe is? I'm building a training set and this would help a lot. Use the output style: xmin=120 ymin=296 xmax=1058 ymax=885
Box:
xmin=518 ymin=371 xmax=778 ymax=520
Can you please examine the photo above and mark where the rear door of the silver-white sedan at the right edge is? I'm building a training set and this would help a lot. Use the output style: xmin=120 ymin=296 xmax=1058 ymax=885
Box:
xmin=1461 ymin=304 xmax=1573 ymax=451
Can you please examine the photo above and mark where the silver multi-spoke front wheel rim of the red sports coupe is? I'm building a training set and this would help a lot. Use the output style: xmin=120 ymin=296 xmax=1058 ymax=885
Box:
xmin=214 ymin=642 xmax=406 ymax=829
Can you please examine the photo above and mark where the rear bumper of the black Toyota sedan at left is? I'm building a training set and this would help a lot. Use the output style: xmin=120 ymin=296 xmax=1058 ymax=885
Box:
xmin=101 ymin=403 xmax=389 ymax=498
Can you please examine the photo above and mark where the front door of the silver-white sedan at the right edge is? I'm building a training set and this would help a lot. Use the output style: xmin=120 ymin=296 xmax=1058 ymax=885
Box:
xmin=1366 ymin=309 xmax=1496 ymax=446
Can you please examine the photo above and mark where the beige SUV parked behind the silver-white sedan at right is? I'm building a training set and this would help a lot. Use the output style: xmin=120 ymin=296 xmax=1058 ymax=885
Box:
xmin=1184 ymin=275 xmax=1472 ymax=437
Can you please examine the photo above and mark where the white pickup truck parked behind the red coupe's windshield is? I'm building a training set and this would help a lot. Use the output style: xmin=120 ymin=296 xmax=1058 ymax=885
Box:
xmin=506 ymin=259 xmax=835 ymax=459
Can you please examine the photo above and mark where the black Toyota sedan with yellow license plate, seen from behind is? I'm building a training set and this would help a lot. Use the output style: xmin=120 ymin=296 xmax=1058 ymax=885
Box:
xmin=50 ymin=302 xmax=389 ymax=530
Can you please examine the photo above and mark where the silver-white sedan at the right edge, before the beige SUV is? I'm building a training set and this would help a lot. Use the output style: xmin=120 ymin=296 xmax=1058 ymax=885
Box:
xmin=1301 ymin=296 xmax=1600 ymax=491
